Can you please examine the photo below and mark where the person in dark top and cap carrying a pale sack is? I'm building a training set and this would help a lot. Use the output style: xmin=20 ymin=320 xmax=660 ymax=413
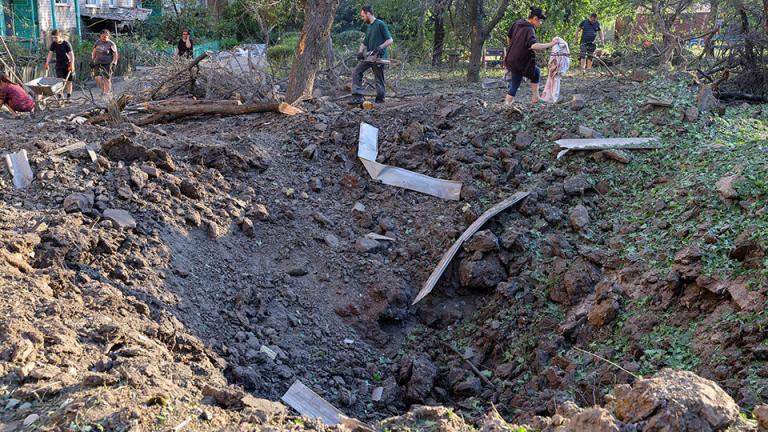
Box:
xmin=504 ymin=7 xmax=557 ymax=105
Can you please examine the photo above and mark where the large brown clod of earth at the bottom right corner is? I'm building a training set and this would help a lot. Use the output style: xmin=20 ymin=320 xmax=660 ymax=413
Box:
xmin=614 ymin=369 xmax=739 ymax=432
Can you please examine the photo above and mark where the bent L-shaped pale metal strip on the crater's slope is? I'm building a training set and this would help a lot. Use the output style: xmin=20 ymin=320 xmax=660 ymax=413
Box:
xmin=357 ymin=123 xmax=462 ymax=201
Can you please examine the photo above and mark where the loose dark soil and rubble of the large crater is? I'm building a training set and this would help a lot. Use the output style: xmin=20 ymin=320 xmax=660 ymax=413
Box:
xmin=0 ymin=68 xmax=768 ymax=431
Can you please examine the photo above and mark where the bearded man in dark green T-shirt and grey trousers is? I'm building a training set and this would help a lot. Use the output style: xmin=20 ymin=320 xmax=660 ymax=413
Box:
xmin=350 ymin=6 xmax=394 ymax=105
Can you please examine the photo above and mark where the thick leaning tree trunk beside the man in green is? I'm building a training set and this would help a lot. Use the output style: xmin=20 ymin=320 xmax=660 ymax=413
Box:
xmin=286 ymin=0 xmax=340 ymax=103
